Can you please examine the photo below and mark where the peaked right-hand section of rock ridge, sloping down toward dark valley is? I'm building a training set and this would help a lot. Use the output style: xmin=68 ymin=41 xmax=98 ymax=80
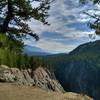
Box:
xmin=34 ymin=67 xmax=63 ymax=92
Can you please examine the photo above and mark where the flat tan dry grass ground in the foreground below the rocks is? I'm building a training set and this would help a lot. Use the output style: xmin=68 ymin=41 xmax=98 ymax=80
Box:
xmin=0 ymin=83 xmax=92 ymax=100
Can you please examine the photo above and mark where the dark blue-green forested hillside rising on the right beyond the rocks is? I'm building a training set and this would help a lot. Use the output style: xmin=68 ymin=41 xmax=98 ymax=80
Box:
xmin=44 ymin=40 xmax=100 ymax=100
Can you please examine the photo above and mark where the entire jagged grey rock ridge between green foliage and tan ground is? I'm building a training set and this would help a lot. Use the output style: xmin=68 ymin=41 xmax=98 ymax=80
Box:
xmin=0 ymin=65 xmax=64 ymax=92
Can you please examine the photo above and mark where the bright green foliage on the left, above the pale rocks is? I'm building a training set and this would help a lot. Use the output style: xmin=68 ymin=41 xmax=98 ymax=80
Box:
xmin=0 ymin=34 xmax=47 ymax=70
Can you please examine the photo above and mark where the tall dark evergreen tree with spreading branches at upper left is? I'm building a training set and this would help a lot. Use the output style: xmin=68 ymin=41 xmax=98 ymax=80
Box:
xmin=0 ymin=0 xmax=52 ymax=40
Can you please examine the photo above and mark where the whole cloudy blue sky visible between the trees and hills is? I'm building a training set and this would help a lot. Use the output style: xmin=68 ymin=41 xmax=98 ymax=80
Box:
xmin=25 ymin=0 xmax=100 ymax=53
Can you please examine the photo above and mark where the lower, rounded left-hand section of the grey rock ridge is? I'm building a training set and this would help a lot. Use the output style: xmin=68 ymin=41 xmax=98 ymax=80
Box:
xmin=0 ymin=65 xmax=34 ymax=85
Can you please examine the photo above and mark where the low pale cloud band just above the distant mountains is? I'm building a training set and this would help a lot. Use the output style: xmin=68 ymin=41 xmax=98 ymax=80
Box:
xmin=30 ymin=39 xmax=76 ymax=53
